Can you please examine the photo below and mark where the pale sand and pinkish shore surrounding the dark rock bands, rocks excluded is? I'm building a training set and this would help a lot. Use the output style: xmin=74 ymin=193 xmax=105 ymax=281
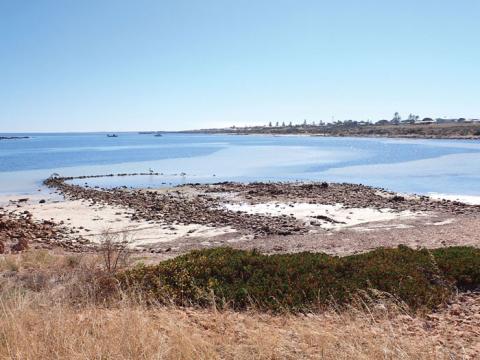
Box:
xmin=0 ymin=181 xmax=480 ymax=257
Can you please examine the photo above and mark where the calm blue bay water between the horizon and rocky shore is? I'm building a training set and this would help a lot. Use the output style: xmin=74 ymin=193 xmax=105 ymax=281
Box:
xmin=0 ymin=133 xmax=480 ymax=200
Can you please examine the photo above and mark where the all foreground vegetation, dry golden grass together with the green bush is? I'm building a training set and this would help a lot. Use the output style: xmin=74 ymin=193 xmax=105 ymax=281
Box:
xmin=0 ymin=246 xmax=479 ymax=359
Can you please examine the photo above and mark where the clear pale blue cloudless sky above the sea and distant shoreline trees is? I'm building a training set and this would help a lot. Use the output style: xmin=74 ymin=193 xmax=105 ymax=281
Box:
xmin=0 ymin=0 xmax=480 ymax=132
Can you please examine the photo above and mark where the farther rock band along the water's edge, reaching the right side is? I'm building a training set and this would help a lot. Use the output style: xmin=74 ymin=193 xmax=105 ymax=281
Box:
xmin=194 ymin=182 xmax=480 ymax=215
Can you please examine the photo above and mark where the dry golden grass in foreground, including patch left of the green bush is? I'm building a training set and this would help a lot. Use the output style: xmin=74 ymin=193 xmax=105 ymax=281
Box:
xmin=0 ymin=251 xmax=474 ymax=360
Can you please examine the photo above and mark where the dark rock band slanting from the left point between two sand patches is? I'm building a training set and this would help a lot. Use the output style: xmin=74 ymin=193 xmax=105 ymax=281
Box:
xmin=45 ymin=177 xmax=307 ymax=237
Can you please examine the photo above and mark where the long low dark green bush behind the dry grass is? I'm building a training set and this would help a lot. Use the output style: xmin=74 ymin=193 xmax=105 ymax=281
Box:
xmin=118 ymin=246 xmax=480 ymax=311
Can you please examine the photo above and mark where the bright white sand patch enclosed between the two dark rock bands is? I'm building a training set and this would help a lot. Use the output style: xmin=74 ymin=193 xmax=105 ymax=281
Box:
xmin=223 ymin=202 xmax=420 ymax=230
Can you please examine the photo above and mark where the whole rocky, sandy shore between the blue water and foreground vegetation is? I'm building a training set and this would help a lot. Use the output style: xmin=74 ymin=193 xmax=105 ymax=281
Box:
xmin=0 ymin=179 xmax=480 ymax=258
